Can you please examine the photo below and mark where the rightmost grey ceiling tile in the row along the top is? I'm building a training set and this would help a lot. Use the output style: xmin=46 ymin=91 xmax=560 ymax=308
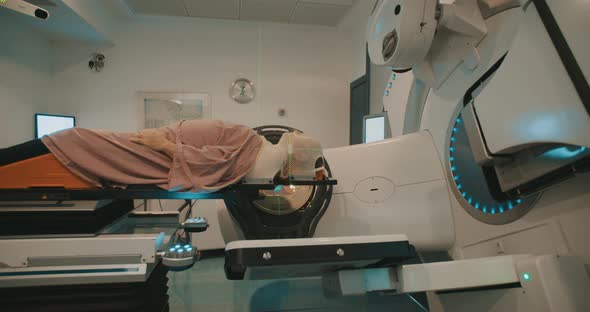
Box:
xmin=291 ymin=2 xmax=350 ymax=26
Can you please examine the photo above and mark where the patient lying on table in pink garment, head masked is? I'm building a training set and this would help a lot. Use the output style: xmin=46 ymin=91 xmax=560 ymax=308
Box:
xmin=0 ymin=120 xmax=323 ymax=191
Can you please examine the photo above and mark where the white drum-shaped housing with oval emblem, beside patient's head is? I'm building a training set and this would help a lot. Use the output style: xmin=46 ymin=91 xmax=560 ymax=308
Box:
xmin=217 ymin=131 xmax=455 ymax=251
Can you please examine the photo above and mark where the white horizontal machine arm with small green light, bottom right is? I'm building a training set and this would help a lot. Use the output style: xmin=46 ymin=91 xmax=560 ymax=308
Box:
xmin=324 ymin=255 xmax=590 ymax=312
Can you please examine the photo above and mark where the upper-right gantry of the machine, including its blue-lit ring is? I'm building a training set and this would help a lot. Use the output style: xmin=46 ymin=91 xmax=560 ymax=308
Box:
xmin=367 ymin=1 xmax=590 ymax=224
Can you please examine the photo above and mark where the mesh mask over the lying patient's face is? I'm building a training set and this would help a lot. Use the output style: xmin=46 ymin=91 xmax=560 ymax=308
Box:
xmin=281 ymin=133 xmax=324 ymax=177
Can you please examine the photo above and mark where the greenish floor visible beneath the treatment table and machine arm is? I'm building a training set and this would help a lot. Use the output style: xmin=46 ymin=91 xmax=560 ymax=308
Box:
xmin=168 ymin=257 xmax=424 ymax=312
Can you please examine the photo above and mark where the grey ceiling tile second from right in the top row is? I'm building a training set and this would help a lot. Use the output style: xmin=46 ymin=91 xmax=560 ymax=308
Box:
xmin=240 ymin=0 xmax=297 ymax=23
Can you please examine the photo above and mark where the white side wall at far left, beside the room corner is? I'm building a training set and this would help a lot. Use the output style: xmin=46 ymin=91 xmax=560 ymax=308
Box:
xmin=0 ymin=18 xmax=51 ymax=148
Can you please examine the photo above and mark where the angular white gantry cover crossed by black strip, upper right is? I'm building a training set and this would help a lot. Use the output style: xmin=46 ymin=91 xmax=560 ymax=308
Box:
xmin=474 ymin=1 xmax=590 ymax=153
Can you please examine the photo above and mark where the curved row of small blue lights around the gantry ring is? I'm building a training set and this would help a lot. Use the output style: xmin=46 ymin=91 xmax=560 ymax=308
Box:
xmin=449 ymin=117 xmax=522 ymax=215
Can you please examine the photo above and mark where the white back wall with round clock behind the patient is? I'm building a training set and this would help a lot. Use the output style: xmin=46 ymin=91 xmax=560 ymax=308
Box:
xmin=50 ymin=17 xmax=351 ymax=147
